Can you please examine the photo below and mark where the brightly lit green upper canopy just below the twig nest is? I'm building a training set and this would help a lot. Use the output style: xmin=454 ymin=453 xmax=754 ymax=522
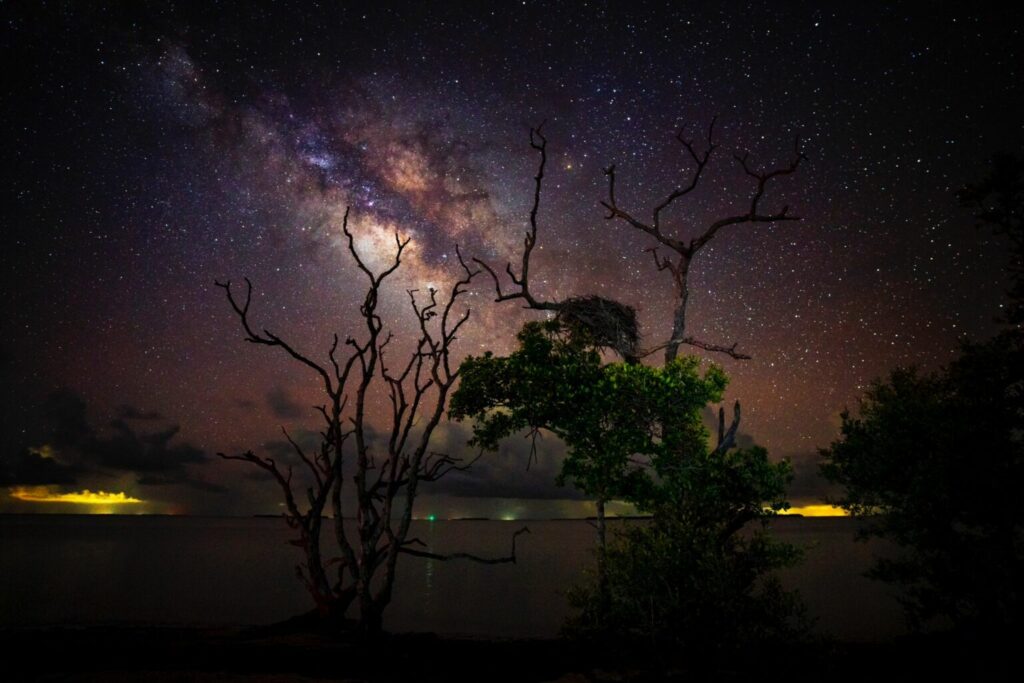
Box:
xmin=449 ymin=321 xmax=727 ymax=504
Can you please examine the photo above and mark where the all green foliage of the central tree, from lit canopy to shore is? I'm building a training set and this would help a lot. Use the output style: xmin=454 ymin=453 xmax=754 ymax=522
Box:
xmin=450 ymin=321 xmax=798 ymax=645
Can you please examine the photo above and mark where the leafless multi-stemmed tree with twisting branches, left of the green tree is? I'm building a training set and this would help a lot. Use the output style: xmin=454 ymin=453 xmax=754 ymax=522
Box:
xmin=216 ymin=210 xmax=528 ymax=633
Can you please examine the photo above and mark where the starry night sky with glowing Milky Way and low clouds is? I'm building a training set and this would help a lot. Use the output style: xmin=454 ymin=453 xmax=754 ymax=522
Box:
xmin=0 ymin=2 xmax=1024 ymax=516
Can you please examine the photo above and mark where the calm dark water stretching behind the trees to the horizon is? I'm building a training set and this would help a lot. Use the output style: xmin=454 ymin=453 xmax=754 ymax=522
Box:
xmin=0 ymin=515 xmax=903 ymax=640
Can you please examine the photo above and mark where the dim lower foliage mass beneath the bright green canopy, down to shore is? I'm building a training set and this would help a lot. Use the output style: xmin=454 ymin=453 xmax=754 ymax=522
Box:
xmin=568 ymin=446 xmax=807 ymax=650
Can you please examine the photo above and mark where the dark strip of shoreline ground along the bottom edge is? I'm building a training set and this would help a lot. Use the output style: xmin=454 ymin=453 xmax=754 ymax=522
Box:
xmin=0 ymin=627 xmax=1024 ymax=683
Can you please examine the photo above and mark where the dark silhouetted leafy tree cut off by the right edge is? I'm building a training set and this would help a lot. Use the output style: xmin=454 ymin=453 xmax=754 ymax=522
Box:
xmin=821 ymin=157 xmax=1024 ymax=636
